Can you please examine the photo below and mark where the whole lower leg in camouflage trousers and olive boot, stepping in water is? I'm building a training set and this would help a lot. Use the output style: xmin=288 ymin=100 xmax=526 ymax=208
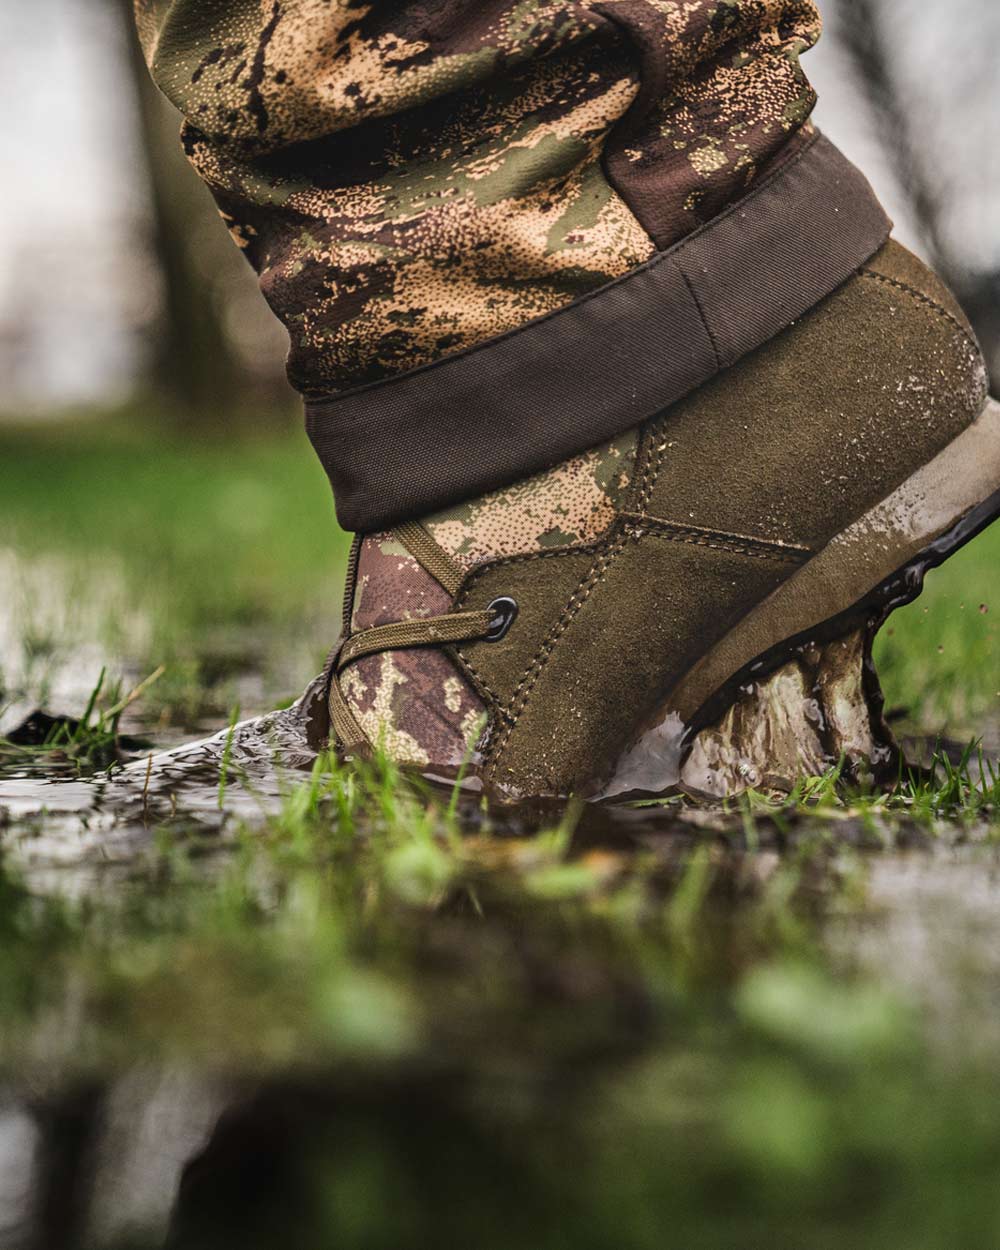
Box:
xmin=128 ymin=0 xmax=998 ymax=795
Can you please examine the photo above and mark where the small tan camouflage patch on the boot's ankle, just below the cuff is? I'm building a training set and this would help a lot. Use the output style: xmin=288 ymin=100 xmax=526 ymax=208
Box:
xmin=424 ymin=430 xmax=638 ymax=568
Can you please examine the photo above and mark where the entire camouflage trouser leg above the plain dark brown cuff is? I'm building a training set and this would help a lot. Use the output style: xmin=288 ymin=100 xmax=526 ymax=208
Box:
xmin=136 ymin=0 xmax=820 ymax=396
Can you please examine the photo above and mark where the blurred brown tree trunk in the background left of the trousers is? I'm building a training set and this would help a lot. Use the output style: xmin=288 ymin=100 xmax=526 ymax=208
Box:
xmin=110 ymin=0 xmax=290 ymax=429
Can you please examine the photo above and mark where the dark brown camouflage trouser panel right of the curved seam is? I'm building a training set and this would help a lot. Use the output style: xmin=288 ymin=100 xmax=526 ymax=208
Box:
xmin=605 ymin=0 xmax=821 ymax=249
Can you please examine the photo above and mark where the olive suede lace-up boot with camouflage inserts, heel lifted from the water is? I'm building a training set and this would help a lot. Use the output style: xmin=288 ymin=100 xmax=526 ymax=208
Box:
xmin=328 ymin=241 xmax=1000 ymax=799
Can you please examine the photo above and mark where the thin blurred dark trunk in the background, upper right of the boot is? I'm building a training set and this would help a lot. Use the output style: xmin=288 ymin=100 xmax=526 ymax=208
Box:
xmin=836 ymin=0 xmax=1000 ymax=386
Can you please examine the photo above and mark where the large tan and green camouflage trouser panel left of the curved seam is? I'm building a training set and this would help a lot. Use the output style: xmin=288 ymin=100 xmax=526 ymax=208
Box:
xmin=140 ymin=0 xmax=654 ymax=394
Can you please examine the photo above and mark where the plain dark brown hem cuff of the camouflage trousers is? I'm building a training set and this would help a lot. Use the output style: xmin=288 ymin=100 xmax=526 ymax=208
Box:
xmin=306 ymin=136 xmax=891 ymax=531
